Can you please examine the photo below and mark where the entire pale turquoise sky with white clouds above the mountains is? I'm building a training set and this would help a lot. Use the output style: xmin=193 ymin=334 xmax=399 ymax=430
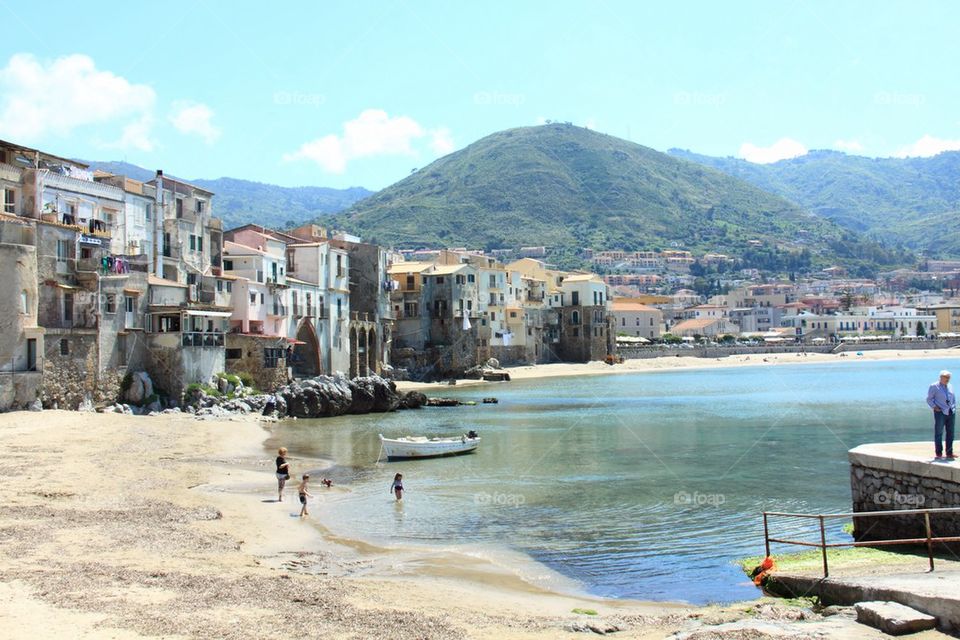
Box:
xmin=0 ymin=0 xmax=960 ymax=189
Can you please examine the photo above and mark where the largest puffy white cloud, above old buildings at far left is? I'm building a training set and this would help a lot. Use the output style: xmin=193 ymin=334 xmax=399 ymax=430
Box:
xmin=0 ymin=53 xmax=156 ymax=148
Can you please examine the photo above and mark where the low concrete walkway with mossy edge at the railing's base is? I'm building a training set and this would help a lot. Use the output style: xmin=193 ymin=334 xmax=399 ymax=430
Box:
xmin=767 ymin=571 xmax=960 ymax=631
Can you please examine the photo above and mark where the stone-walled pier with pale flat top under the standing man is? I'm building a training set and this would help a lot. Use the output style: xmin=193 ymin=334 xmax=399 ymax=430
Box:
xmin=850 ymin=442 xmax=960 ymax=540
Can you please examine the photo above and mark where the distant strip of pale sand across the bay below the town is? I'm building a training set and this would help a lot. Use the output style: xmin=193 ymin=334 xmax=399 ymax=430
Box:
xmin=396 ymin=349 xmax=960 ymax=392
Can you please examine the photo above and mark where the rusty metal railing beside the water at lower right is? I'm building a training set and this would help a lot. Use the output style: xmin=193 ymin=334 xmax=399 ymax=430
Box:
xmin=763 ymin=507 xmax=960 ymax=578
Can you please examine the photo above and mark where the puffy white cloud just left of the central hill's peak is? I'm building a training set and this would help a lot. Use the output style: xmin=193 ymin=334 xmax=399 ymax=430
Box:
xmin=283 ymin=109 xmax=453 ymax=173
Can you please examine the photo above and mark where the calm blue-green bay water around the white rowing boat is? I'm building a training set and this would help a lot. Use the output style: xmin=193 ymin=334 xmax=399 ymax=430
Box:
xmin=270 ymin=356 xmax=951 ymax=603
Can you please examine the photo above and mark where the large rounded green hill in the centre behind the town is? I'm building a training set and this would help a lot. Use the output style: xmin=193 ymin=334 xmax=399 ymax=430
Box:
xmin=333 ymin=124 xmax=909 ymax=274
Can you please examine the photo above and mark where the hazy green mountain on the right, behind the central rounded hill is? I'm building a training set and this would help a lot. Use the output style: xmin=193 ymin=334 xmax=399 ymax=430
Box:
xmin=668 ymin=149 xmax=960 ymax=257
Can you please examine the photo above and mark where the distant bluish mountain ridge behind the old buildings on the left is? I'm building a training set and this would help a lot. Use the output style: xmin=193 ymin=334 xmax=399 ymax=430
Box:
xmin=81 ymin=160 xmax=372 ymax=229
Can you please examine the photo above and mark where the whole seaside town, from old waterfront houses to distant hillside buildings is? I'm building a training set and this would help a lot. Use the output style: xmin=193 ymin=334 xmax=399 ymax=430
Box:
xmin=0 ymin=141 xmax=960 ymax=410
